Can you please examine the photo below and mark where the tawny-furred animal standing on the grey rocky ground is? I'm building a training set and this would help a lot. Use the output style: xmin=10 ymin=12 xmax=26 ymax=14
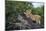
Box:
xmin=24 ymin=11 xmax=41 ymax=24
